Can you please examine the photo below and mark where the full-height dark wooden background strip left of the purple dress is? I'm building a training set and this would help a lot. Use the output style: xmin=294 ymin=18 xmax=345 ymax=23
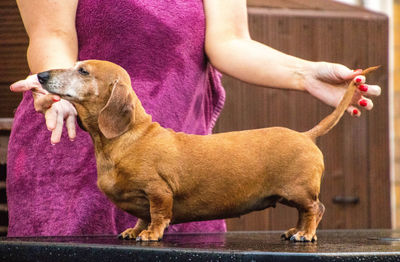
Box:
xmin=0 ymin=0 xmax=29 ymax=236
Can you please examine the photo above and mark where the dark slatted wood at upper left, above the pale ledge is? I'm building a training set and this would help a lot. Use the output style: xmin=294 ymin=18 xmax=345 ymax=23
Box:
xmin=0 ymin=0 xmax=29 ymax=117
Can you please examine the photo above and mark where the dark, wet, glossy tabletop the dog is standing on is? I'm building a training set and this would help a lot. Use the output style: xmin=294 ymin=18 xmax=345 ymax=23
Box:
xmin=0 ymin=230 xmax=400 ymax=262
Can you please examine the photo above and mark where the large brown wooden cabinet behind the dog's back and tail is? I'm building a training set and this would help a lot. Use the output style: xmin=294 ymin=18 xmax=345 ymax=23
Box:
xmin=215 ymin=6 xmax=391 ymax=230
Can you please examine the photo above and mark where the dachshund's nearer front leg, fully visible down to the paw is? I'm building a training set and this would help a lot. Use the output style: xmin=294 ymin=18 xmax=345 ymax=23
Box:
xmin=136 ymin=190 xmax=173 ymax=241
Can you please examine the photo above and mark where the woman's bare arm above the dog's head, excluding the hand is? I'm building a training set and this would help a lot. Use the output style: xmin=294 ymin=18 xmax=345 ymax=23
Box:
xmin=17 ymin=0 xmax=78 ymax=73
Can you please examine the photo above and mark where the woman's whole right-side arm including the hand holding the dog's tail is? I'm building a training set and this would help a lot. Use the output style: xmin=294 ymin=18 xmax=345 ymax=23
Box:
xmin=204 ymin=0 xmax=380 ymax=115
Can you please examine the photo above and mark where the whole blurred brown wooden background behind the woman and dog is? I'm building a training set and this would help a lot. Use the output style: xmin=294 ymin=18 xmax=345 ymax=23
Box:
xmin=0 ymin=0 xmax=400 ymax=235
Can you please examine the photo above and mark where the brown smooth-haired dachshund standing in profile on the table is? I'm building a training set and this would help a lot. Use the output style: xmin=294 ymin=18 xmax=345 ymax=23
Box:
xmin=38 ymin=60 xmax=375 ymax=241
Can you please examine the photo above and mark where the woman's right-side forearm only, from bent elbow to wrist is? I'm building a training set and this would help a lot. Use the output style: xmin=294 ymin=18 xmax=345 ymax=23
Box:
xmin=208 ymin=38 xmax=312 ymax=90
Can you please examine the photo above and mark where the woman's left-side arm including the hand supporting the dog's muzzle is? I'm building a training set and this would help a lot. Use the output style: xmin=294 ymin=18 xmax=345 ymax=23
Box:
xmin=12 ymin=0 xmax=78 ymax=144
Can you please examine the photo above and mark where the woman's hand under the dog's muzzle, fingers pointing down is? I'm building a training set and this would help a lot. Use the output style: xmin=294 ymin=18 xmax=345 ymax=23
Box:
xmin=10 ymin=75 xmax=77 ymax=145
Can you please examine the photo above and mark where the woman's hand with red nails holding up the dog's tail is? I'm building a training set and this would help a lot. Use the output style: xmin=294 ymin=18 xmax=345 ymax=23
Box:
xmin=302 ymin=62 xmax=381 ymax=116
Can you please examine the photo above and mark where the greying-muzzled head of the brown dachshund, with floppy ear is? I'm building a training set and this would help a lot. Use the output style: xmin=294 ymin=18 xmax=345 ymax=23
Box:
xmin=38 ymin=60 xmax=137 ymax=138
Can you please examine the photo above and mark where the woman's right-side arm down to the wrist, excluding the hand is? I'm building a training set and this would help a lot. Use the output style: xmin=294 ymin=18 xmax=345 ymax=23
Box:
xmin=204 ymin=0 xmax=310 ymax=90
